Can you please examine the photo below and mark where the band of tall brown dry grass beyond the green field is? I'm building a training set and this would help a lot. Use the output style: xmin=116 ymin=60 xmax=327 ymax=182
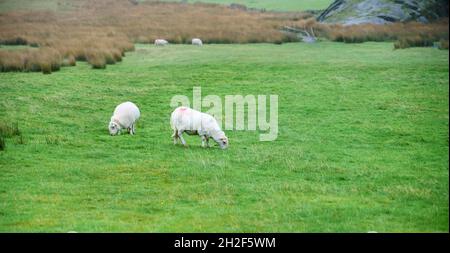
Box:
xmin=0 ymin=0 xmax=448 ymax=73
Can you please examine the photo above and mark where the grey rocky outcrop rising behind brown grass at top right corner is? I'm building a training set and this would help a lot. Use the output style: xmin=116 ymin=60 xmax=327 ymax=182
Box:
xmin=317 ymin=0 xmax=448 ymax=25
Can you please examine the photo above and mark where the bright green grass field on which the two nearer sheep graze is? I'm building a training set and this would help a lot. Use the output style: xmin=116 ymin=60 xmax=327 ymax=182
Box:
xmin=0 ymin=42 xmax=449 ymax=232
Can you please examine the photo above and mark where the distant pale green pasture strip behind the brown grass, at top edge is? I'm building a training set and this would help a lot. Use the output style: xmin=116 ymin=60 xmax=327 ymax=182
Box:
xmin=158 ymin=0 xmax=333 ymax=11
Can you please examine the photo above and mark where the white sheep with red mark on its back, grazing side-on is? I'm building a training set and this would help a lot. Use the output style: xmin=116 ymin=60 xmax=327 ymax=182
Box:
xmin=170 ymin=106 xmax=228 ymax=149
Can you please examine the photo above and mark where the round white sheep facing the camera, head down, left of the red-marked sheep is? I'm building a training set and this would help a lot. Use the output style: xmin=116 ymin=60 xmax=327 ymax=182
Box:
xmin=108 ymin=102 xmax=141 ymax=135
